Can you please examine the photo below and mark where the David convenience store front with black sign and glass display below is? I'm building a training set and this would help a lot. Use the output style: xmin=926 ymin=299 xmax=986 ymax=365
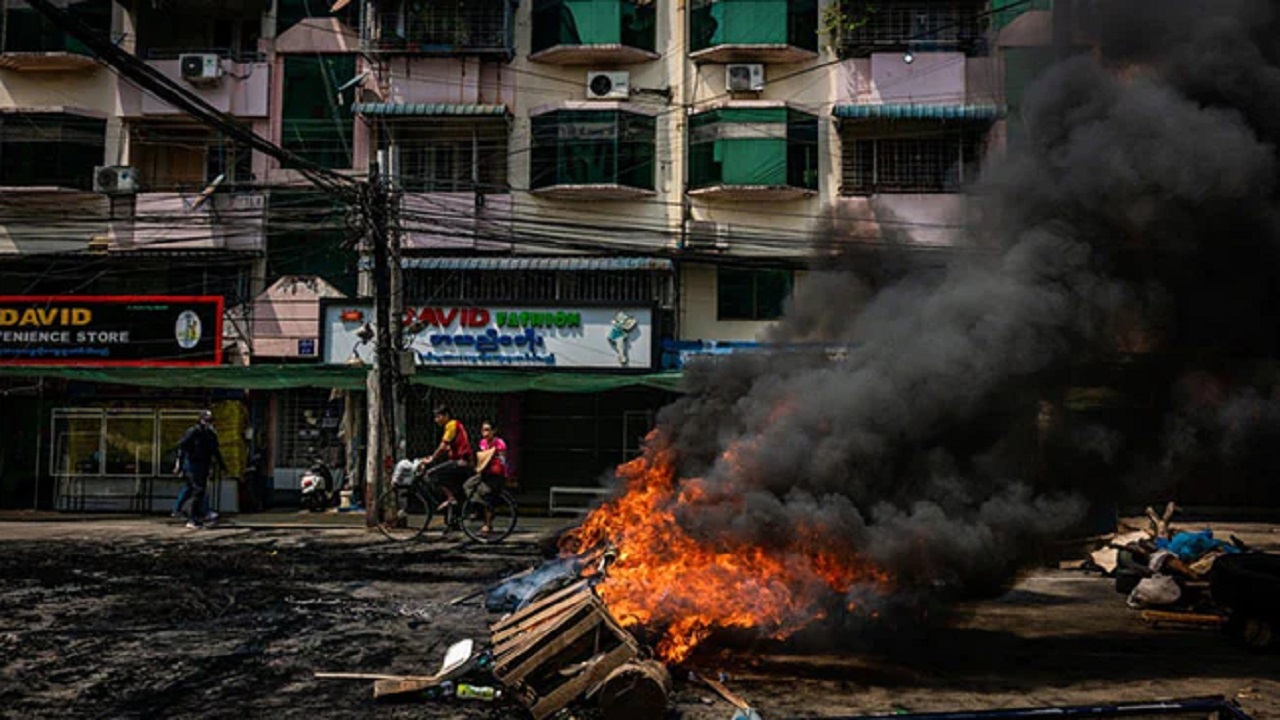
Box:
xmin=0 ymin=296 xmax=240 ymax=512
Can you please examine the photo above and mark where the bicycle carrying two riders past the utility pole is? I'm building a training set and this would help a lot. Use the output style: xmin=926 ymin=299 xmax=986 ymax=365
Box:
xmin=376 ymin=456 xmax=517 ymax=544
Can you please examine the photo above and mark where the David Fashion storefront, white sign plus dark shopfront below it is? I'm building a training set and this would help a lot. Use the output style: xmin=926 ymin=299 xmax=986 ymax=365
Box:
xmin=321 ymin=300 xmax=680 ymax=502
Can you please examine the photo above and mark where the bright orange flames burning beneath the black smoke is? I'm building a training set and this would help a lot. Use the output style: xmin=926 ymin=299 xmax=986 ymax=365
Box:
xmin=572 ymin=435 xmax=888 ymax=662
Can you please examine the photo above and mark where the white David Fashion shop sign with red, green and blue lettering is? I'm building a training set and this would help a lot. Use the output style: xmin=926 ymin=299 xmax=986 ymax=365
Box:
xmin=320 ymin=300 xmax=655 ymax=370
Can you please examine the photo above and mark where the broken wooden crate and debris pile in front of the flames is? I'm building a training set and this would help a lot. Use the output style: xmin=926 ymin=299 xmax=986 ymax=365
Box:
xmin=316 ymin=548 xmax=763 ymax=720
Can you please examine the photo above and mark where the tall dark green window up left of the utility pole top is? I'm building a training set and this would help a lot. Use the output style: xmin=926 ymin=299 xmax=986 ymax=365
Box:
xmin=280 ymin=55 xmax=356 ymax=168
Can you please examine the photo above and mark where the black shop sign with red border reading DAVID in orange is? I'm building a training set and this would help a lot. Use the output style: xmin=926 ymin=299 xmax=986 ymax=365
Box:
xmin=0 ymin=295 xmax=223 ymax=366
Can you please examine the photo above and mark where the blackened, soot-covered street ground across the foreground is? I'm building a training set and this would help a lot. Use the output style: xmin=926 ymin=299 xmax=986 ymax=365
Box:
xmin=0 ymin=520 xmax=1280 ymax=720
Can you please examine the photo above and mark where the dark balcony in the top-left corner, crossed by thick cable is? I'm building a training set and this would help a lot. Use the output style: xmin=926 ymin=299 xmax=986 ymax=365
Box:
xmin=0 ymin=0 xmax=111 ymax=72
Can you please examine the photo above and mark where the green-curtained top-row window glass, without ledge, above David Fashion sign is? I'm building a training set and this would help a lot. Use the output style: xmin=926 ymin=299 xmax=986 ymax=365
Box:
xmin=532 ymin=0 xmax=657 ymax=53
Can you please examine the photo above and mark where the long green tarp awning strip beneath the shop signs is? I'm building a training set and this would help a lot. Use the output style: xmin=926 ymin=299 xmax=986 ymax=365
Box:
xmin=0 ymin=365 xmax=681 ymax=392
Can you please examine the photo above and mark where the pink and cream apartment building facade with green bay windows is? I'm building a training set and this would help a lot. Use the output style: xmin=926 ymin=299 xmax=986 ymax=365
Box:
xmin=0 ymin=0 xmax=1048 ymax=505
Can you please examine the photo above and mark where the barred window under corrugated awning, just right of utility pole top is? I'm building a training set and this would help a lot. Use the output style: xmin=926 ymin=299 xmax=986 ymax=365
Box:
xmin=388 ymin=119 xmax=508 ymax=192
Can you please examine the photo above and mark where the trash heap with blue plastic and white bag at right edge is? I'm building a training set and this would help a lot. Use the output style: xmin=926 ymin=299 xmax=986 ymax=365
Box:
xmin=1084 ymin=502 xmax=1280 ymax=650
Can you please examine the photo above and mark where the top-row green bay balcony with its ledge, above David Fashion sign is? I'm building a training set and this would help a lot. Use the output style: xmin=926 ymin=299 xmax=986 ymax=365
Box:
xmin=529 ymin=0 xmax=658 ymax=65
